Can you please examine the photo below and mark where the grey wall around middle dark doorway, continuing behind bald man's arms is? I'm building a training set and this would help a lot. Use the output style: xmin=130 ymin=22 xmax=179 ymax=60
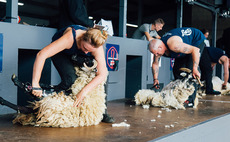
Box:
xmin=107 ymin=37 xmax=170 ymax=100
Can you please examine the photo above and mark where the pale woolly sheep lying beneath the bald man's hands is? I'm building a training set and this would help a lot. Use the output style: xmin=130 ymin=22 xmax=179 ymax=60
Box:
xmin=135 ymin=74 xmax=198 ymax=109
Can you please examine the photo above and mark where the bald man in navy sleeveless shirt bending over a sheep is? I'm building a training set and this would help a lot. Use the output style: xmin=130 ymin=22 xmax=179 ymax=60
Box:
xmin=149 ymin=27 xmax=220 ymax=106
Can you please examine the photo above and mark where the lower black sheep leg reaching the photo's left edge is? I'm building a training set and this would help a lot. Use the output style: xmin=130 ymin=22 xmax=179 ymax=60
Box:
xmin=0 ymin=97 xmax=34 ymax=114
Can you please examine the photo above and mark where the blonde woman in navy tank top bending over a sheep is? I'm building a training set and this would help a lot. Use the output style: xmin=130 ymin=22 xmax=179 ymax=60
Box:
xmin=32 ymin=25 xmax=114 ymax=123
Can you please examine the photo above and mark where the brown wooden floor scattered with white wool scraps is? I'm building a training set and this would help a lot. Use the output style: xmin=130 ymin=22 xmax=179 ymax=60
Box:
xmin=0 ymin=96 xmax=230 ymax=142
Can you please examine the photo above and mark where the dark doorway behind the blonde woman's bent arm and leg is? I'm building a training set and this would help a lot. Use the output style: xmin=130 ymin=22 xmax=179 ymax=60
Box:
xmin=17 ymin=49 xmax=51 ymax=106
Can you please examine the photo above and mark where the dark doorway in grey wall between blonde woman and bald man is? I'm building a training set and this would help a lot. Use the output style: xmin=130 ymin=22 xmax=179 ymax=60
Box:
xmin=125 ymin=55 xmax=142 ymax=98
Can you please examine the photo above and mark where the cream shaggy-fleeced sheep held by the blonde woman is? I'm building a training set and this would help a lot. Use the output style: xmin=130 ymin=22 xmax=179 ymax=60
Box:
xmin=13 ymin=67 xmax=106 ymax=127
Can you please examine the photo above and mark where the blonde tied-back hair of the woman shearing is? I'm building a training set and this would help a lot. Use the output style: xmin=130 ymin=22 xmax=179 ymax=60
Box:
xmin=80 ymin=28 xmax=108 ymax=48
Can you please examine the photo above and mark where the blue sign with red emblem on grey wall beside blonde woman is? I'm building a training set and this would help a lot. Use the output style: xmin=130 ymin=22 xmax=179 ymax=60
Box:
xmin=106 ymin=44 xmax=119 ymax=71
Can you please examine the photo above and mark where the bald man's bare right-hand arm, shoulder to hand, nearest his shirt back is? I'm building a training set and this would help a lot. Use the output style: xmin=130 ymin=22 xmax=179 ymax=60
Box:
xmin=167 ymin=36 xmax=200 ymax=78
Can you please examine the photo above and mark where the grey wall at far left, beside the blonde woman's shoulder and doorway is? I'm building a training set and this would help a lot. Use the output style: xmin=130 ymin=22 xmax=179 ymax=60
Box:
xmin=0 ymin=22 xmax=56 ymax=114
